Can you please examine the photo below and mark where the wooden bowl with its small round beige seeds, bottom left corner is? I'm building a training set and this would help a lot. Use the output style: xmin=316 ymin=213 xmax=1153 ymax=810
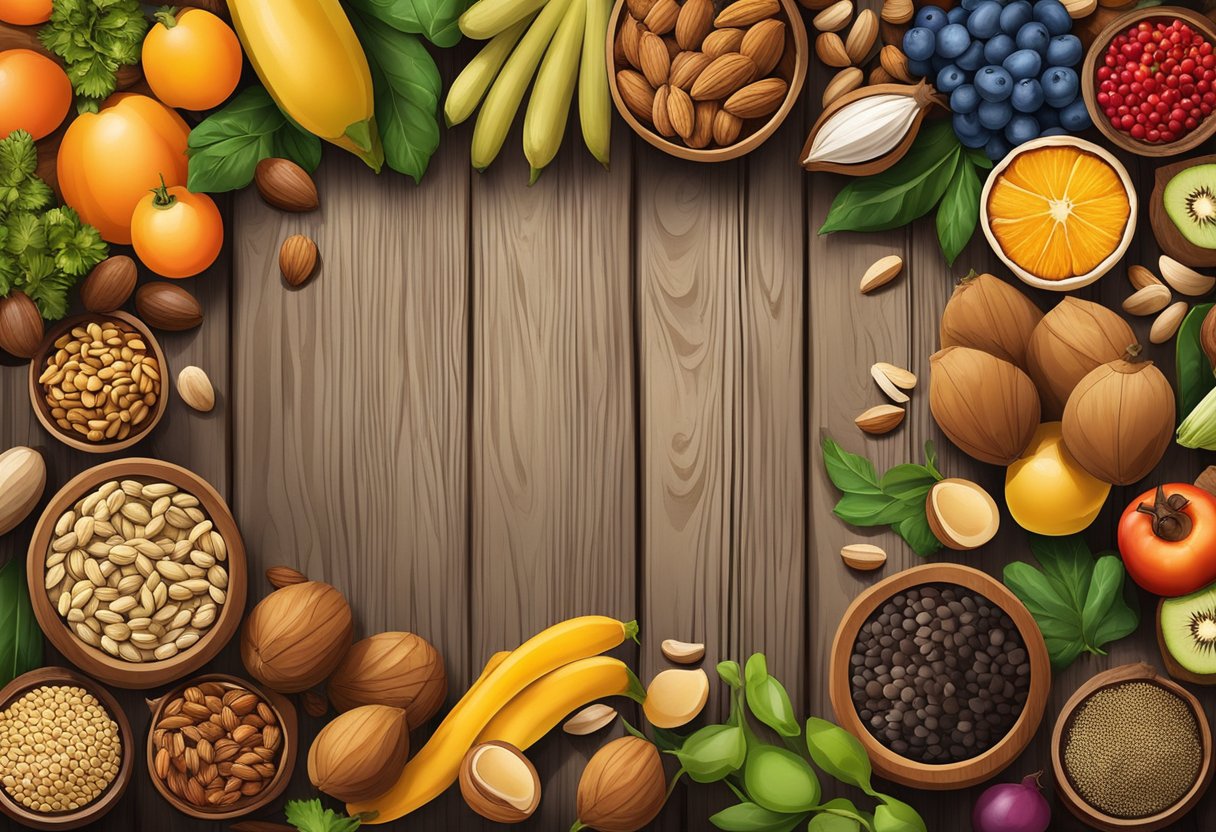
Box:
xmin=0 ymin=668 xmax=134 ymax=830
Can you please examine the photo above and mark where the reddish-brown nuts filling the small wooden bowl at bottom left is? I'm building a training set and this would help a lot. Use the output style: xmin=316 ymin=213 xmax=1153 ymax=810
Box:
xmin=152 ymin=682 xmax=283 ymax=809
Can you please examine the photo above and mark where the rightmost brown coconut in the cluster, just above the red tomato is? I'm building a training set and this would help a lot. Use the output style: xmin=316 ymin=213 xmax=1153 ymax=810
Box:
xmin=1063 ymin=345 xmax=1173 ymax=485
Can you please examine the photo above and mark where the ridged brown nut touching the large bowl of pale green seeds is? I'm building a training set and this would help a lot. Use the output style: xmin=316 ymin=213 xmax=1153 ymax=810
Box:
xmin=241 ymin=580 xmax=355 ymax=693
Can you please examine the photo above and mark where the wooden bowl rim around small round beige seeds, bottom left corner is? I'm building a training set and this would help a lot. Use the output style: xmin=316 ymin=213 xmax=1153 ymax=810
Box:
xmin=0 ymin=668 xmax=135 ymax=830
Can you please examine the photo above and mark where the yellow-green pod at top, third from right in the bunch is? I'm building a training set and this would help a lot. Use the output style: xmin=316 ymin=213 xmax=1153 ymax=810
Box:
xmin=472 ymin=0 xmax=570 ymax=170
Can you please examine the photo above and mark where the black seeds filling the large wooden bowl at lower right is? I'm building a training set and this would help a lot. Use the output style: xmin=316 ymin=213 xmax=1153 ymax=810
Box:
xmin=850 ymin=585 xmax=1030 ymax=763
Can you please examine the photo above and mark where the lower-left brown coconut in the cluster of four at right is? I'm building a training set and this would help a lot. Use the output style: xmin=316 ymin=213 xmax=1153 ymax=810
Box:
xmin=929 ymin=347 xmax=1040 ymax=465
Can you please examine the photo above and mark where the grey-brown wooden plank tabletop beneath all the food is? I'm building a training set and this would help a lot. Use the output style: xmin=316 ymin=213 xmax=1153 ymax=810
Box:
xmin=0 ymin=37 xmax=1216 ymax=832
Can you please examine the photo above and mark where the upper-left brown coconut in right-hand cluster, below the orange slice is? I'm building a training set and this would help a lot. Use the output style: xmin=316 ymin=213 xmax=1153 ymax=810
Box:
xmin=939 ymin=271 xmax=1043 ymax=370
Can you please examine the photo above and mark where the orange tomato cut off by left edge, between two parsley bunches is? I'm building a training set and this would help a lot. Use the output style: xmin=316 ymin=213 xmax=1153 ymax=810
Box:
xmin=0 ymin=49 xmax=72 ymax=139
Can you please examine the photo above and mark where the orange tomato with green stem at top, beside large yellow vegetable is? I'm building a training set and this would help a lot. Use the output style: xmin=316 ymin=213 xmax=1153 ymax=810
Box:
xmin=143 ymin=9 xmax=241 ymax=109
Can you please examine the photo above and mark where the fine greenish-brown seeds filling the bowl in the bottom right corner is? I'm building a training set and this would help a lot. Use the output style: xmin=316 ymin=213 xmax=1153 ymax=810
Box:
xmin=1064 ymin=682 xmax=1203 ymax=819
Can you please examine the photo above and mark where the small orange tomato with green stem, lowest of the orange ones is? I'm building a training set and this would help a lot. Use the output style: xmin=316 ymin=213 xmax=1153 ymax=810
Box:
xmin=131 ymin=185 xmax=224 ymax=277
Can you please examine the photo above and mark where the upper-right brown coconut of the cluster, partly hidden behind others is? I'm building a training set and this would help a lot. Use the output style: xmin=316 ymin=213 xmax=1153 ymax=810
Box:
xmin=1026 ymin=298 xmax=1136 ymax=421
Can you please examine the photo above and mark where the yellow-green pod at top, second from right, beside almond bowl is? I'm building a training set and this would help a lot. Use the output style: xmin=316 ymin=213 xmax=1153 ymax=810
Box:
xmin=524 ymin=0 xmax=587 ymax=185
